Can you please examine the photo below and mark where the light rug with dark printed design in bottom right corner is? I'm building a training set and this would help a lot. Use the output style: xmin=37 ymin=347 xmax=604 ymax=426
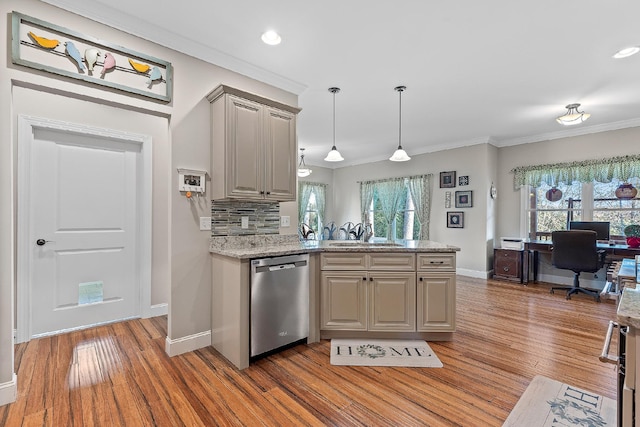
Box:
xmin=503 ymin=375 xmax=617 ymax=427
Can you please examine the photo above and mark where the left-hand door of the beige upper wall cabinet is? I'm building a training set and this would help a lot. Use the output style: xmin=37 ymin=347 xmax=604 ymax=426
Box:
xmin=225 ymin=95 xmax=265 ymax=199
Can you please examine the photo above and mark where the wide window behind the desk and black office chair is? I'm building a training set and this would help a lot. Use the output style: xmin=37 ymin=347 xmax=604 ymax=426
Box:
xmin=526 ymin=178 xmax=640 ymax=239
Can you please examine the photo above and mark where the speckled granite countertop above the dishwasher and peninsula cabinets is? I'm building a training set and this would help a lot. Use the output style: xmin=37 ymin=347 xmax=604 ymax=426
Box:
xmin=209 ymin=234 xmax=460 ymax=259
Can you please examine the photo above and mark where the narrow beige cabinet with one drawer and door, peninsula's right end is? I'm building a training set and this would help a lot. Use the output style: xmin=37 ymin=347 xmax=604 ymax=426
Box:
xmin=416 ymin=253 xmax=456 ymax=332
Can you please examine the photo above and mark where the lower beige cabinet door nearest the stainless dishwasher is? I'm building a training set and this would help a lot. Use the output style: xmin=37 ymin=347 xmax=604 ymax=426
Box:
xmin=320 ymin=271 xmax=367 ymax=331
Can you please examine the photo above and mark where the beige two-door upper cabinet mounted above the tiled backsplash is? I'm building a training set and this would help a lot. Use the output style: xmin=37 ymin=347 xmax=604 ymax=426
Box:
xmin=207 ymin=85 xmax=300 ymax=202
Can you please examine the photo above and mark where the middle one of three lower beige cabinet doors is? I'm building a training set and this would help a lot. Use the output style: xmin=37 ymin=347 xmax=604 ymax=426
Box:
xmin=368 ymin=272 xmax=416 ymax=331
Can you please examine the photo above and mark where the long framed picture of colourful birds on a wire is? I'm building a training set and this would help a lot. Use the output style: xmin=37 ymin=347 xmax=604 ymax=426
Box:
xmin=11 ymin=12 xmax=173 ymax=102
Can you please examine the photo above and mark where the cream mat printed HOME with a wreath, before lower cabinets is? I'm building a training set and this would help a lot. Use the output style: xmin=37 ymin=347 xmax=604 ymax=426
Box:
xmin=331 ymin=339 xmax=442 ymax=368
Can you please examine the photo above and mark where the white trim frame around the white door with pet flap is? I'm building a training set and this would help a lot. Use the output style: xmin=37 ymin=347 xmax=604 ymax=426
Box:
xmin=15 ymin=115 xmax=152 ymax=343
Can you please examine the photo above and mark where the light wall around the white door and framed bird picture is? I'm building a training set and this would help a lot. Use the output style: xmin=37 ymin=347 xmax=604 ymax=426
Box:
xmin=0 ymin=0 xmax=297 ymax=403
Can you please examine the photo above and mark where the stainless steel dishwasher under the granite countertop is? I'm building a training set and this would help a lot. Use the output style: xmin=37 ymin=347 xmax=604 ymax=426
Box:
xmin=250 ymin=254 xmax=309 ymax=357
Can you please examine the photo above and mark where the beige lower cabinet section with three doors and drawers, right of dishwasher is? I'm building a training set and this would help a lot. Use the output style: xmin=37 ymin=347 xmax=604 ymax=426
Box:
xmin=320 ymin=253 xmax=456 ymax=332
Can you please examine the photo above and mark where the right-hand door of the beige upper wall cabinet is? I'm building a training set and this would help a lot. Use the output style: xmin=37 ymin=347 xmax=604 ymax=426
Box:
xmin=264 ymin=107 xmax=298 ymax=201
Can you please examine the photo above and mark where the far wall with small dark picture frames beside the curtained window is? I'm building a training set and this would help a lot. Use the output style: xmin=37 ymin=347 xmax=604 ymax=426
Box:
xmin=331 ymin=144 xmax=497 ymax=277
